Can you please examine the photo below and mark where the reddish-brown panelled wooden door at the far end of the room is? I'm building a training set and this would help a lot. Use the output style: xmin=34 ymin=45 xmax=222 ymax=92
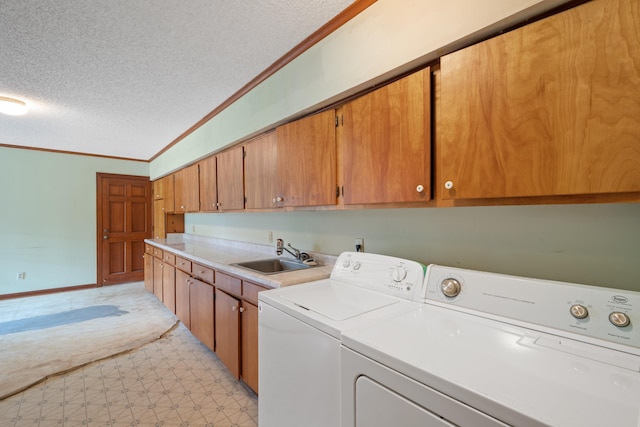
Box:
xmin=96 ymin=174 xmax=152 ymax=286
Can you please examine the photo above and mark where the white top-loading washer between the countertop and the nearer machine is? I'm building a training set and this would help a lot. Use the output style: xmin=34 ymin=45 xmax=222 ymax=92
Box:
xmin=258 ymin=252 xmax=425 ymax=427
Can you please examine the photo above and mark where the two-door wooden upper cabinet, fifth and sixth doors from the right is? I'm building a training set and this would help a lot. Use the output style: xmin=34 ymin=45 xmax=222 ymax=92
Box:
xmin=200 ymin=146 xmax=244 ymax=212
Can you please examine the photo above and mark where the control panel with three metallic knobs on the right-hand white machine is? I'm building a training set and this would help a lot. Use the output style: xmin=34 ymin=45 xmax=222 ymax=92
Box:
xmin=423 ymin=265 xmax=640 ymax=349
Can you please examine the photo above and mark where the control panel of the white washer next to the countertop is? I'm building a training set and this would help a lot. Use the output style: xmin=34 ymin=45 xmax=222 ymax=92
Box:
xmin=331 ymin=252 xmax=426 ymax=300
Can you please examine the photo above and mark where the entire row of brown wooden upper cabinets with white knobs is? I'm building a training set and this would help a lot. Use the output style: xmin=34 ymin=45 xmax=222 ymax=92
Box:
xmin=156 ymin=0 xmax=640 ymax=219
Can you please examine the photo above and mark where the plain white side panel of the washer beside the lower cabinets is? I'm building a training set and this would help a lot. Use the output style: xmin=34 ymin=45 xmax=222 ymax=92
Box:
xmin=258 ymin=302 xmax=340 ymax=427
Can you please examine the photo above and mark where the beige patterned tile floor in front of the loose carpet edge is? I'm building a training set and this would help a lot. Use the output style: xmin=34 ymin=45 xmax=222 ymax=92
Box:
xmin=0 ymin=324 xmax=258 ymax=427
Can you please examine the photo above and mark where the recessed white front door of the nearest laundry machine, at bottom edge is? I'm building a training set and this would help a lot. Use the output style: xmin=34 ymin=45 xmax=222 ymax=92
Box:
xmin=356 ymin=376 xmax=453 ymax=427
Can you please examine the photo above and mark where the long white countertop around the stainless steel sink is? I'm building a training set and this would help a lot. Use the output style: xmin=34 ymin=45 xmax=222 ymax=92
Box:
xmin=145 ymin=234 xmax=337 ymax=288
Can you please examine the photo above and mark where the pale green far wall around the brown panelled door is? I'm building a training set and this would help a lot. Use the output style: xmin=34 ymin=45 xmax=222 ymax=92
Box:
xmin=0 ymin=147 xmax=149 ymax=294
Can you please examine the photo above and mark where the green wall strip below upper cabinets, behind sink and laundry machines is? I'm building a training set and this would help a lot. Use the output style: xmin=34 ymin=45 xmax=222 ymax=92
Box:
xmin=185 ymin=204 xmax=640 ymax=291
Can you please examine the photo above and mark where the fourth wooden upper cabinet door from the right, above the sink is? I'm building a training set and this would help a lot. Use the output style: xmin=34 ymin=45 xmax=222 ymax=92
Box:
xmin=244 ymin=132 xmax=278 ymax=209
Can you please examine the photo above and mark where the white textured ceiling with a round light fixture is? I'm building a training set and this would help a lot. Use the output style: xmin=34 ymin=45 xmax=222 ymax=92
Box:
xmin=0 ymin=0 xmax=353 ymax=160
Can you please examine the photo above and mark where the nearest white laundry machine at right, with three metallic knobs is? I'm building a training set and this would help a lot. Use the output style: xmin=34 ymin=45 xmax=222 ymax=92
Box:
xmin=341 ymin=265 xmax=640 ymax=427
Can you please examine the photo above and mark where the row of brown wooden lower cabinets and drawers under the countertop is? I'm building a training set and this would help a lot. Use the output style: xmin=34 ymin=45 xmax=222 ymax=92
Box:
xmin=145 ymin=248 xmax=266 ymax=393
